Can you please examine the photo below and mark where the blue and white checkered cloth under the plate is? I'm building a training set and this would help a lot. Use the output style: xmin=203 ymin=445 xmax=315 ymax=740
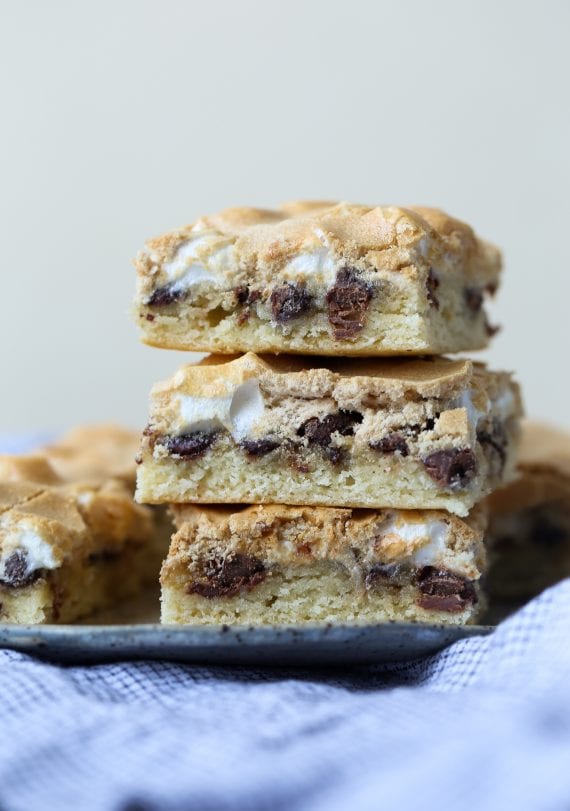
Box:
xmin=0 ymin=438 xmax=570 ymax=811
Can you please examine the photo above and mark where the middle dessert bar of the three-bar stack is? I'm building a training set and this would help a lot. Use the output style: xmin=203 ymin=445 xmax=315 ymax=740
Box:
xmin=137 ymin=354 xmax=521 ymax=515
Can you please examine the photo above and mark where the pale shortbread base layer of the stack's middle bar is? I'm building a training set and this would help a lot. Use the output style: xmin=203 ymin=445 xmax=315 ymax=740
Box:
xmin=136 ymin=439 xmax=514 ymax=516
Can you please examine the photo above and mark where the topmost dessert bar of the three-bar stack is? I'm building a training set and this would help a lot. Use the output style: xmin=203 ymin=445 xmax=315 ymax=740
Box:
xmin=135 ymin=202 xmax=501 ymax=355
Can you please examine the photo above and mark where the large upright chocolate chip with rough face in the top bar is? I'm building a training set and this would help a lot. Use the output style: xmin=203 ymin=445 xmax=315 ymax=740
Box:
xmin=327 ymin=268 xmax=374 ymax=341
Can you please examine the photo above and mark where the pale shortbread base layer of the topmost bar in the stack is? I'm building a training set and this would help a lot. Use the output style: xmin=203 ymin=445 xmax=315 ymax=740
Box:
xmin=135 ymin=274 xmax=489 ymax=356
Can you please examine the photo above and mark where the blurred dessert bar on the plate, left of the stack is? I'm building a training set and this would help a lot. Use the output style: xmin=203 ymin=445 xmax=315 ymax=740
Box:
xmin=0 ymin=432 xmax=166 ymax=623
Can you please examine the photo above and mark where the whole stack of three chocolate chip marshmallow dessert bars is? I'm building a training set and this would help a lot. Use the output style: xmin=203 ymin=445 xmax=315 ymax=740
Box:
xmin=136 ymin=202 xmax=521 ymax=624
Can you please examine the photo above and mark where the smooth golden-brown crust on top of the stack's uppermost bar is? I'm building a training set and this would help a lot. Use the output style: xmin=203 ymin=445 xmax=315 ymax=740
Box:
xmin=137 ymin=201 xmax=500 ymax=282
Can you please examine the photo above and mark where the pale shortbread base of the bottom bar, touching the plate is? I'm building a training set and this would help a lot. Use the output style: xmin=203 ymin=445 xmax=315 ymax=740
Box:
xmin=161 ymin=563 xmax=484 ymax=625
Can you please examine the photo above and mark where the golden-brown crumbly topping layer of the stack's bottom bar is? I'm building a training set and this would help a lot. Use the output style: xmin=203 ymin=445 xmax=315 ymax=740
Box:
xmin=168 ymin=504 xmax=487 ymax=578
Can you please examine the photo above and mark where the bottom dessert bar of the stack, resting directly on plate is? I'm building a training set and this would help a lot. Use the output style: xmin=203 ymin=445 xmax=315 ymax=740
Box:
xmin=161 ymin=505 xmax=486 ymax=624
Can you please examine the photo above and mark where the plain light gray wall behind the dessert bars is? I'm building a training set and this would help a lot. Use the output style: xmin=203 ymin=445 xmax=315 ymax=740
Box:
xmin=0 ymin=0 xmax=570 ymax=431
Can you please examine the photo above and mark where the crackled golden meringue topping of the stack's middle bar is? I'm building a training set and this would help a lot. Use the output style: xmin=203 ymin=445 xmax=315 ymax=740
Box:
xmin=143 ymin=352 xmax=522 ymax=441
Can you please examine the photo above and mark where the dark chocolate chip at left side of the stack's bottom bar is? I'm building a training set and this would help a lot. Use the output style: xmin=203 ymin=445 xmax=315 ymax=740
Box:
xmin=186 ymin=553 xmax=266 ymax=600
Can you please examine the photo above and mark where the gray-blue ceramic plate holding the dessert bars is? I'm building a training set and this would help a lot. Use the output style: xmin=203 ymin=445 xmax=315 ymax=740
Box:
xmin=0 ymin=601 xmax=493 ymax=667
